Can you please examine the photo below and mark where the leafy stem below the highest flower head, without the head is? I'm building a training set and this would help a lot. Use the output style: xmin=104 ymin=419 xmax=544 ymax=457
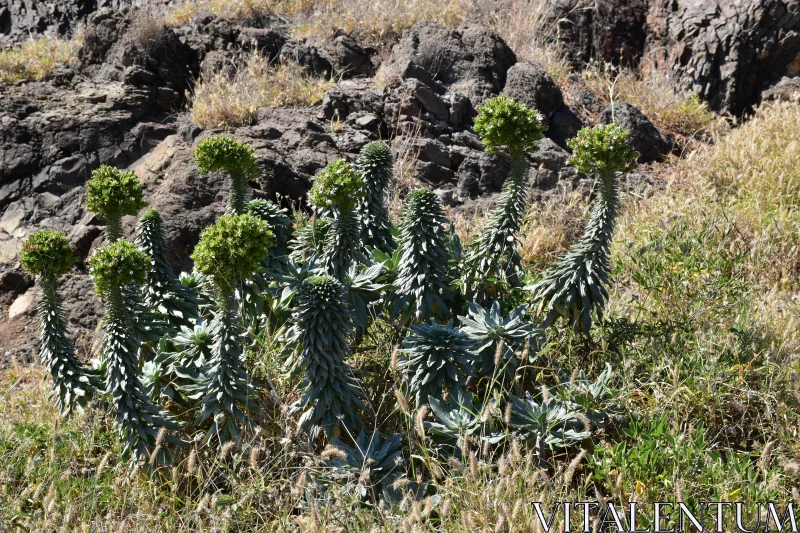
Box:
xmin=465 ymin=152 xmax=528 ymax=302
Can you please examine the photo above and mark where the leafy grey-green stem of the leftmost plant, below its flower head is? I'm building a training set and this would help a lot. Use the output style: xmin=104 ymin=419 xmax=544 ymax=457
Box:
xmin=37 ymin=276 xmax=100 ymax=415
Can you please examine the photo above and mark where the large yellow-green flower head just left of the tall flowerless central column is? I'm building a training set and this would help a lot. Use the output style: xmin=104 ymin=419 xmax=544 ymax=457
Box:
xmin=192 ymin=214 xmax=274 ymax=292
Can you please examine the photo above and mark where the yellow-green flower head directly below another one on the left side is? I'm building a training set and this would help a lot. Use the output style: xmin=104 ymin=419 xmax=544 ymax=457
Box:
xmin=89 ymin=239 xmax=150 ymax=296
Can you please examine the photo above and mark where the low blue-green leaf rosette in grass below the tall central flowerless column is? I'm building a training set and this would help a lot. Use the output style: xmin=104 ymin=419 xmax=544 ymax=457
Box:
xmin=328 ymin=429 xmax=405 ymax=503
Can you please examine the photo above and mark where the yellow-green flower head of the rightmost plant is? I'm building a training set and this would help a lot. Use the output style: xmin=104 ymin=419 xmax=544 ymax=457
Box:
xmin=568 ymin=124 xmax=639 ymax=174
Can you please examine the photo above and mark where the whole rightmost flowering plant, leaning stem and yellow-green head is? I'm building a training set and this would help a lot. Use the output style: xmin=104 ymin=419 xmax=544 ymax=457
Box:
xmin=530 ymin=124 xmax=637 ymax=335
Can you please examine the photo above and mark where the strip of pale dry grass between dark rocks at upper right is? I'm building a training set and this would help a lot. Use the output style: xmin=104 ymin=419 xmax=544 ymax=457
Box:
xmin=583 ymin=65 xmax=725 ymax=137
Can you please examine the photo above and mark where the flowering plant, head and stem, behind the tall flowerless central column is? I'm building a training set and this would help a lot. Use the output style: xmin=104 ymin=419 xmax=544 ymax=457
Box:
xmin=310 ymin=159 xmax=367 ymax=282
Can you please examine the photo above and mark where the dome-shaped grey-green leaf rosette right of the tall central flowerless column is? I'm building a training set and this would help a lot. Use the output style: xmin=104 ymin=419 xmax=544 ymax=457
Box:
xmin=399 ymin=320 xmax=475 ymax=407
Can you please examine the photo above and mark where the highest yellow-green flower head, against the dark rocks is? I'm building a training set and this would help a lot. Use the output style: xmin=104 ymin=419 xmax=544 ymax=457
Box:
xmin=475 ymin=94 xmax=545 ymax=154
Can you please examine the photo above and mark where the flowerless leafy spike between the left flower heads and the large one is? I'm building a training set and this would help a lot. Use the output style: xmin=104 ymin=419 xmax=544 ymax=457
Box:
xmin=136 ymin=208 xmax=198 ymax=328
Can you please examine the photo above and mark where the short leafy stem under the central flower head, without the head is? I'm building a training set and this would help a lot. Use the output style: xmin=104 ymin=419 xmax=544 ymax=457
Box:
xmin=321 ymin=207 xmax=367 ymax=283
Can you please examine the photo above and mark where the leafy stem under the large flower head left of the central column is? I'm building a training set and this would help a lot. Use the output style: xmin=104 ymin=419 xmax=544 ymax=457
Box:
xmin=197 ymin=291 xmax=259 ymax=445
